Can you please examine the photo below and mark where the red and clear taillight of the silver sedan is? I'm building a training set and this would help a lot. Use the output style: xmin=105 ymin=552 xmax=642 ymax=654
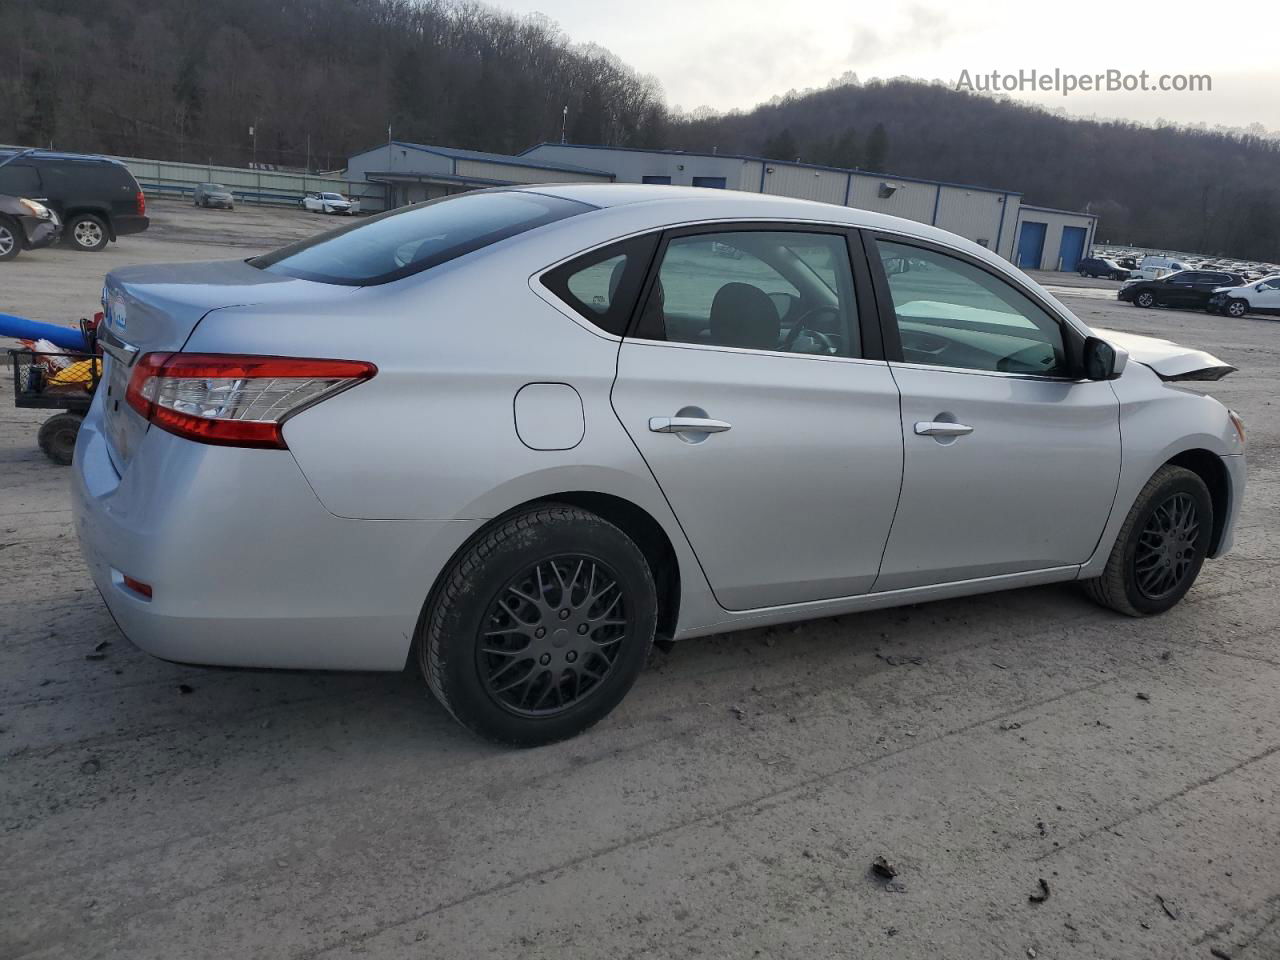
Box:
xmin=124 ymin=353 xmax=378 ymax=449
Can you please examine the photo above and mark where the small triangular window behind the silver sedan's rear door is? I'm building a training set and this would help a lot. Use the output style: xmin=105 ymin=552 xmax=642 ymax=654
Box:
xmin=543 ymin=234 xmax=658 ymax=337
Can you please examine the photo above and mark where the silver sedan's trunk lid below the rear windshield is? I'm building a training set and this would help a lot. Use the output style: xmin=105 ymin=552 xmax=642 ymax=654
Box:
xmin=99 ymin=260 xmax=360 ymax=474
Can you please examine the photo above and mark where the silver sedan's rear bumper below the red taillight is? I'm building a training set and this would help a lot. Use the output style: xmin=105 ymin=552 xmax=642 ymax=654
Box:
xmin=72 ymin=394 xmax=480 ymax=671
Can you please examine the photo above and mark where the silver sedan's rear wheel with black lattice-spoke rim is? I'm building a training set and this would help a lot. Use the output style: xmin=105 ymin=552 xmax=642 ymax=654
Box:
xmin=415 ymin=503 xmax=658 ymax=746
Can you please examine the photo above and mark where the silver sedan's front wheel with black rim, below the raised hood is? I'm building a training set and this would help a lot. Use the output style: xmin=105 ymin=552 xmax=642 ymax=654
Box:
xmin=1084 ymin=465 xmax=1213 ymax=617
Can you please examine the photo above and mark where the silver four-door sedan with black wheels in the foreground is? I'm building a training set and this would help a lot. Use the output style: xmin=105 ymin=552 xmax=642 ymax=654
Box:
xmin=74 ymin=184 xmax=1245 ymax=745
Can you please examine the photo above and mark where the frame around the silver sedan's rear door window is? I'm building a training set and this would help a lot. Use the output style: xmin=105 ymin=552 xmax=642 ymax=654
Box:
xmin=623 ymin=220 xmax=886 ymax=362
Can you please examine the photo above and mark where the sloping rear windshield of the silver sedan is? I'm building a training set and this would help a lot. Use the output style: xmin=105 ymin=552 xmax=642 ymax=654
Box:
xmin=248 ymin=191 xmax=595 ymax=287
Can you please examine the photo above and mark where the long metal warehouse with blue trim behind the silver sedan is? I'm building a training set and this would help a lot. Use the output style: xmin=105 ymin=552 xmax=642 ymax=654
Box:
xmin=347 ymin=141 xmax=1097 ymax=270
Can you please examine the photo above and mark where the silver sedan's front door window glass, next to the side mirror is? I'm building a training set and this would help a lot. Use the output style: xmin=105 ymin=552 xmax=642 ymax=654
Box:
xmin=878 ymin=241 xmax=1069 ymax=376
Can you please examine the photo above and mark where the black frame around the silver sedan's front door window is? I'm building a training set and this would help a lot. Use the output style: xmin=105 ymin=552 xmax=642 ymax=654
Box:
xmin=863 ymin=230 xmax=1089 ymax=383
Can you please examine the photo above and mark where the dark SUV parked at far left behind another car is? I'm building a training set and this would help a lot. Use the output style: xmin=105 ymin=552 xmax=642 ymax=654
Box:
xmin=0 ymin=150 xmax=150 ymax=250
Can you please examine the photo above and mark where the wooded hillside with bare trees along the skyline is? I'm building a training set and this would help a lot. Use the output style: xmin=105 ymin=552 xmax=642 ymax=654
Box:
xmin=0 ymin=0 xmax=1280 ymax=260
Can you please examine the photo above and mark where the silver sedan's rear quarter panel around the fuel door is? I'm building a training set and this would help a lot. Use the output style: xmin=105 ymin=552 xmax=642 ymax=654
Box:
xmin=176 ymin=225 xmax=723 ymax=623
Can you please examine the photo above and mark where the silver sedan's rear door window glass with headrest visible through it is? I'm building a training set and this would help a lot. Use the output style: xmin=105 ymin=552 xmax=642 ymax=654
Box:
xmin=637 ymin=230 xmax=861 ymax=357
